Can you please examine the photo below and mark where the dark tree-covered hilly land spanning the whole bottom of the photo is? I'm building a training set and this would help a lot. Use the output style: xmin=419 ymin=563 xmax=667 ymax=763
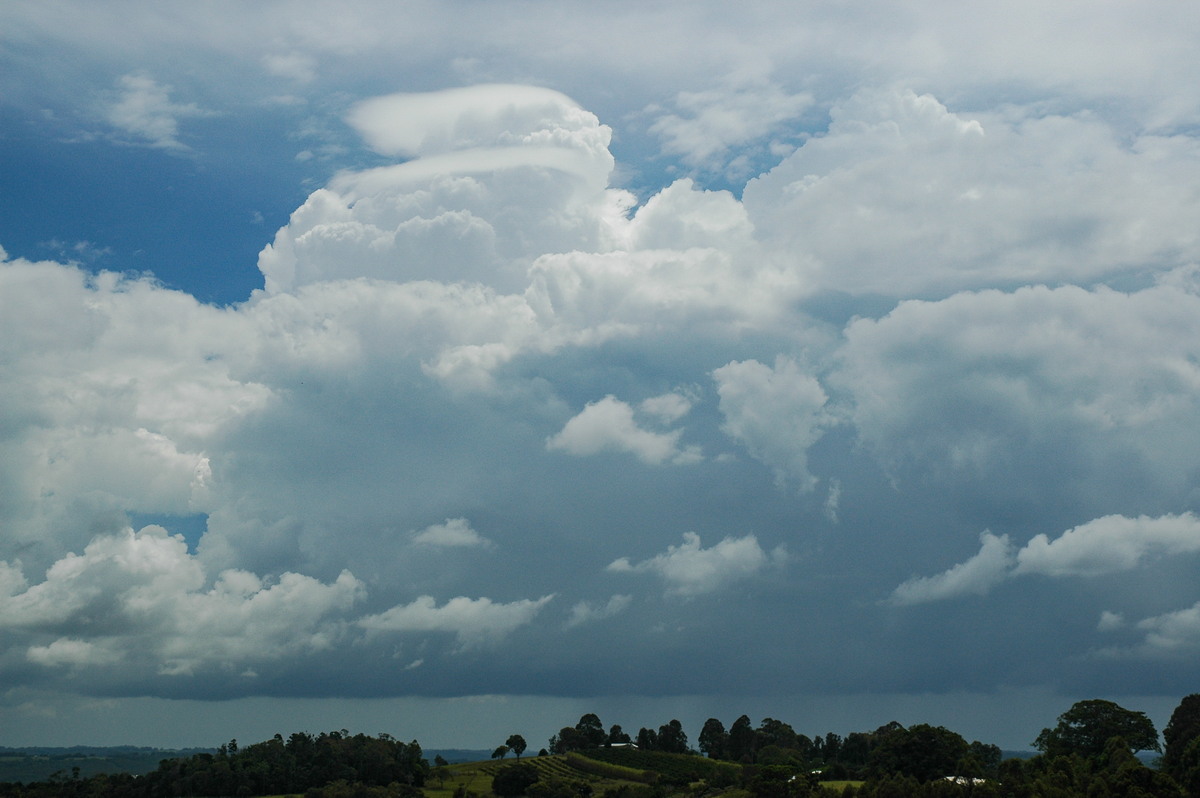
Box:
xmin=0 ymin=694 xmax=1200 ymax=798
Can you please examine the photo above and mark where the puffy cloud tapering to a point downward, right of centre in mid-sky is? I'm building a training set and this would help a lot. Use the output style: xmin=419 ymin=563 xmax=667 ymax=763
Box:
xmin=713 ymin=356 xmax=833 ymax=491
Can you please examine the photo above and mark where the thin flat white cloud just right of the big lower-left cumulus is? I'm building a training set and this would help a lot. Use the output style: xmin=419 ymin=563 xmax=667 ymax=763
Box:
xmin=358 ymin=594 xmax=554 ymax=650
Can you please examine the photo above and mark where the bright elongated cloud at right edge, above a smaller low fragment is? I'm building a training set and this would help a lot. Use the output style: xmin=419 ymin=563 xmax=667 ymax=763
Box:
xmin=1015 ymin=512 xmax=1200 ymax=576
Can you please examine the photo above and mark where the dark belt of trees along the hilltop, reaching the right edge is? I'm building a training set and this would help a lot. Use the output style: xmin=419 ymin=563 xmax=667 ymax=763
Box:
xmin=528 ymin=694 xmax=1200 ymax=798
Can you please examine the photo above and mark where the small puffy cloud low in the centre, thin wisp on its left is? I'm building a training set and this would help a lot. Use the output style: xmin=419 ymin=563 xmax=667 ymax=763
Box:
xmin=607 ymin=532 xmax=786 ymax=598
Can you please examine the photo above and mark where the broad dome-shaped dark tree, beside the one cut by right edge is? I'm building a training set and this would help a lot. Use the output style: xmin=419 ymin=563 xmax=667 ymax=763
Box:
xmin=1033 ymin=698 xmax=1163 ymax=758
